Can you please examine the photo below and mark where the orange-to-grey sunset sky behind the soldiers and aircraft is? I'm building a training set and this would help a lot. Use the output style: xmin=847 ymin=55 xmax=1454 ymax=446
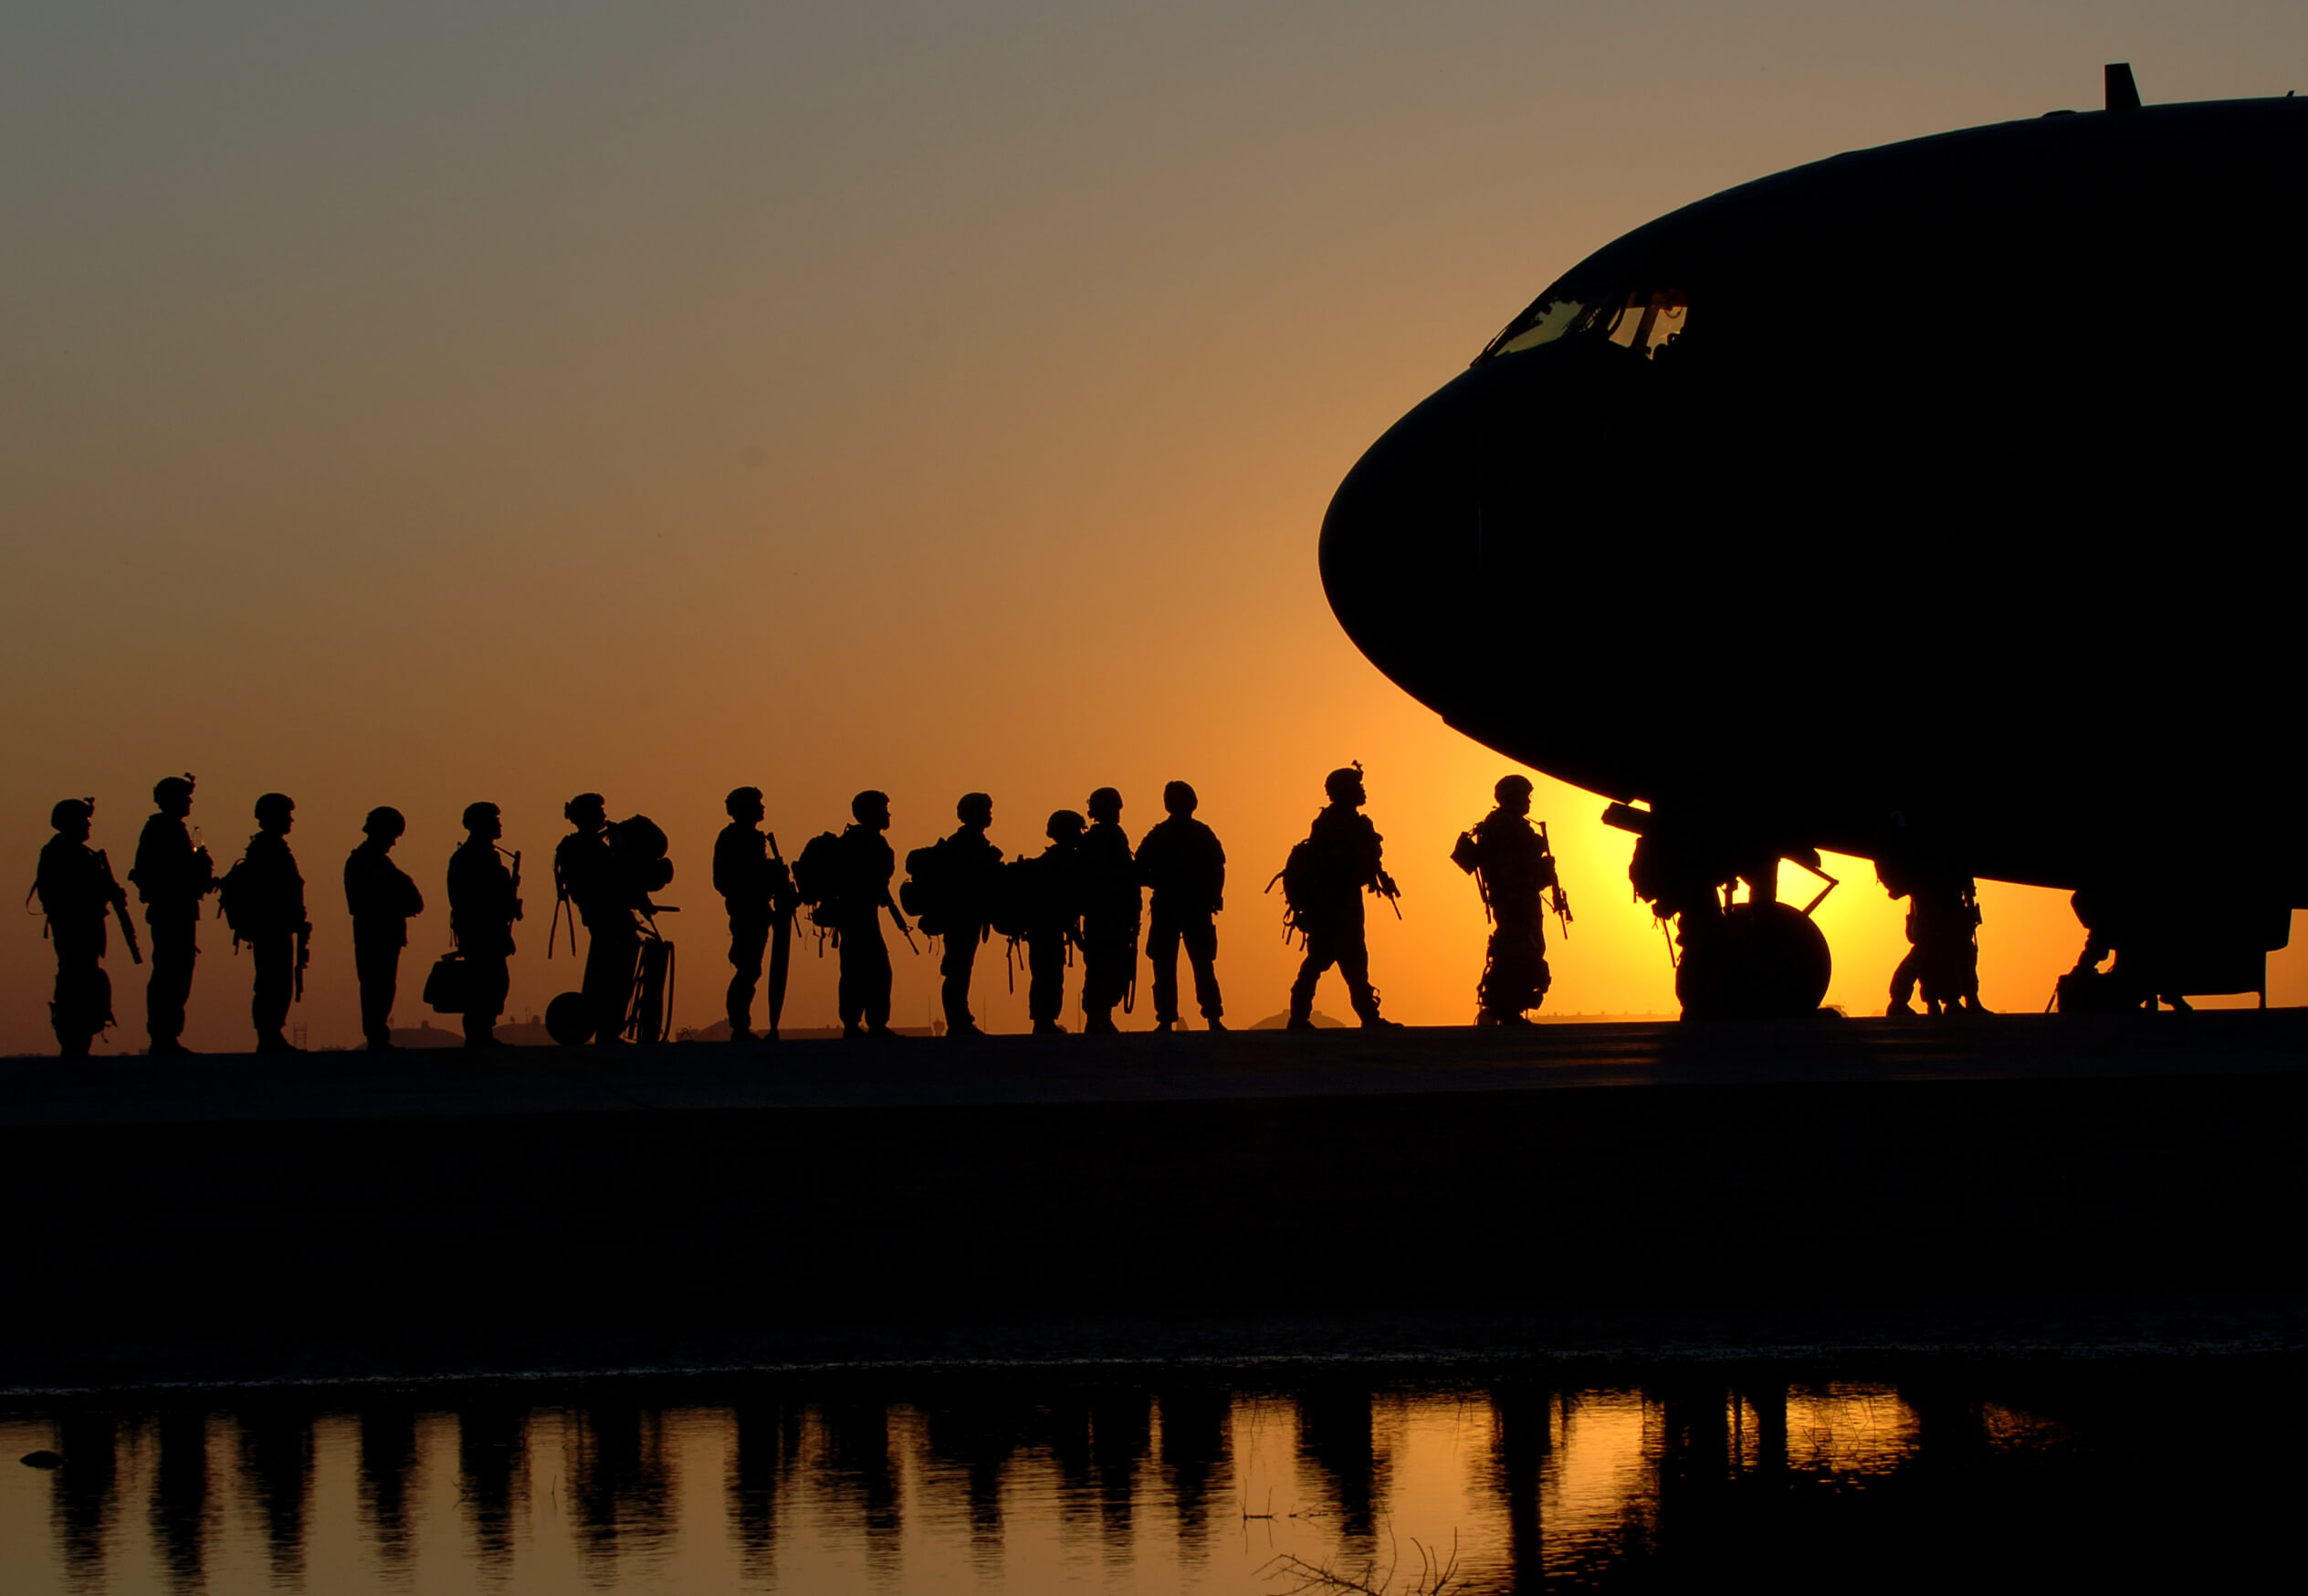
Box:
xmin=0 ymin=0 xmax=2308 ymax=1051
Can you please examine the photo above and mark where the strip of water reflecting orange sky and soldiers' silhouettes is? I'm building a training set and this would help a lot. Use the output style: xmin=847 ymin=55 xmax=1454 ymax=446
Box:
xmin=0 ymin=1368 xmax=2301 ymax=1596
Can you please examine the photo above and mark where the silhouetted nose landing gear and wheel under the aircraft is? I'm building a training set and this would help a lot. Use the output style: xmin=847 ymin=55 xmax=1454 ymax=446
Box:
xmin=1604 ymin=803 xmax=1835 ymax=1019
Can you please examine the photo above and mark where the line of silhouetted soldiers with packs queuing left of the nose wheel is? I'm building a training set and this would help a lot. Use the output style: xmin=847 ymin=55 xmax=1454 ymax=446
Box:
xmin=35 ymin=764 xmax=1569 ymax=1055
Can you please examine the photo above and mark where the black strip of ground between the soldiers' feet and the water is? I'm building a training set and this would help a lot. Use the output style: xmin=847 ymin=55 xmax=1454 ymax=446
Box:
xmin=0 ymin=1009 xmax=2308 ymax=1391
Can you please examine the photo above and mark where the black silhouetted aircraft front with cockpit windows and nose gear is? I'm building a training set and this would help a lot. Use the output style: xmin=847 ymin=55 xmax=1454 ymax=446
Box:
xmin=1320 ymin=65 xmax=2308 ymax=1014
